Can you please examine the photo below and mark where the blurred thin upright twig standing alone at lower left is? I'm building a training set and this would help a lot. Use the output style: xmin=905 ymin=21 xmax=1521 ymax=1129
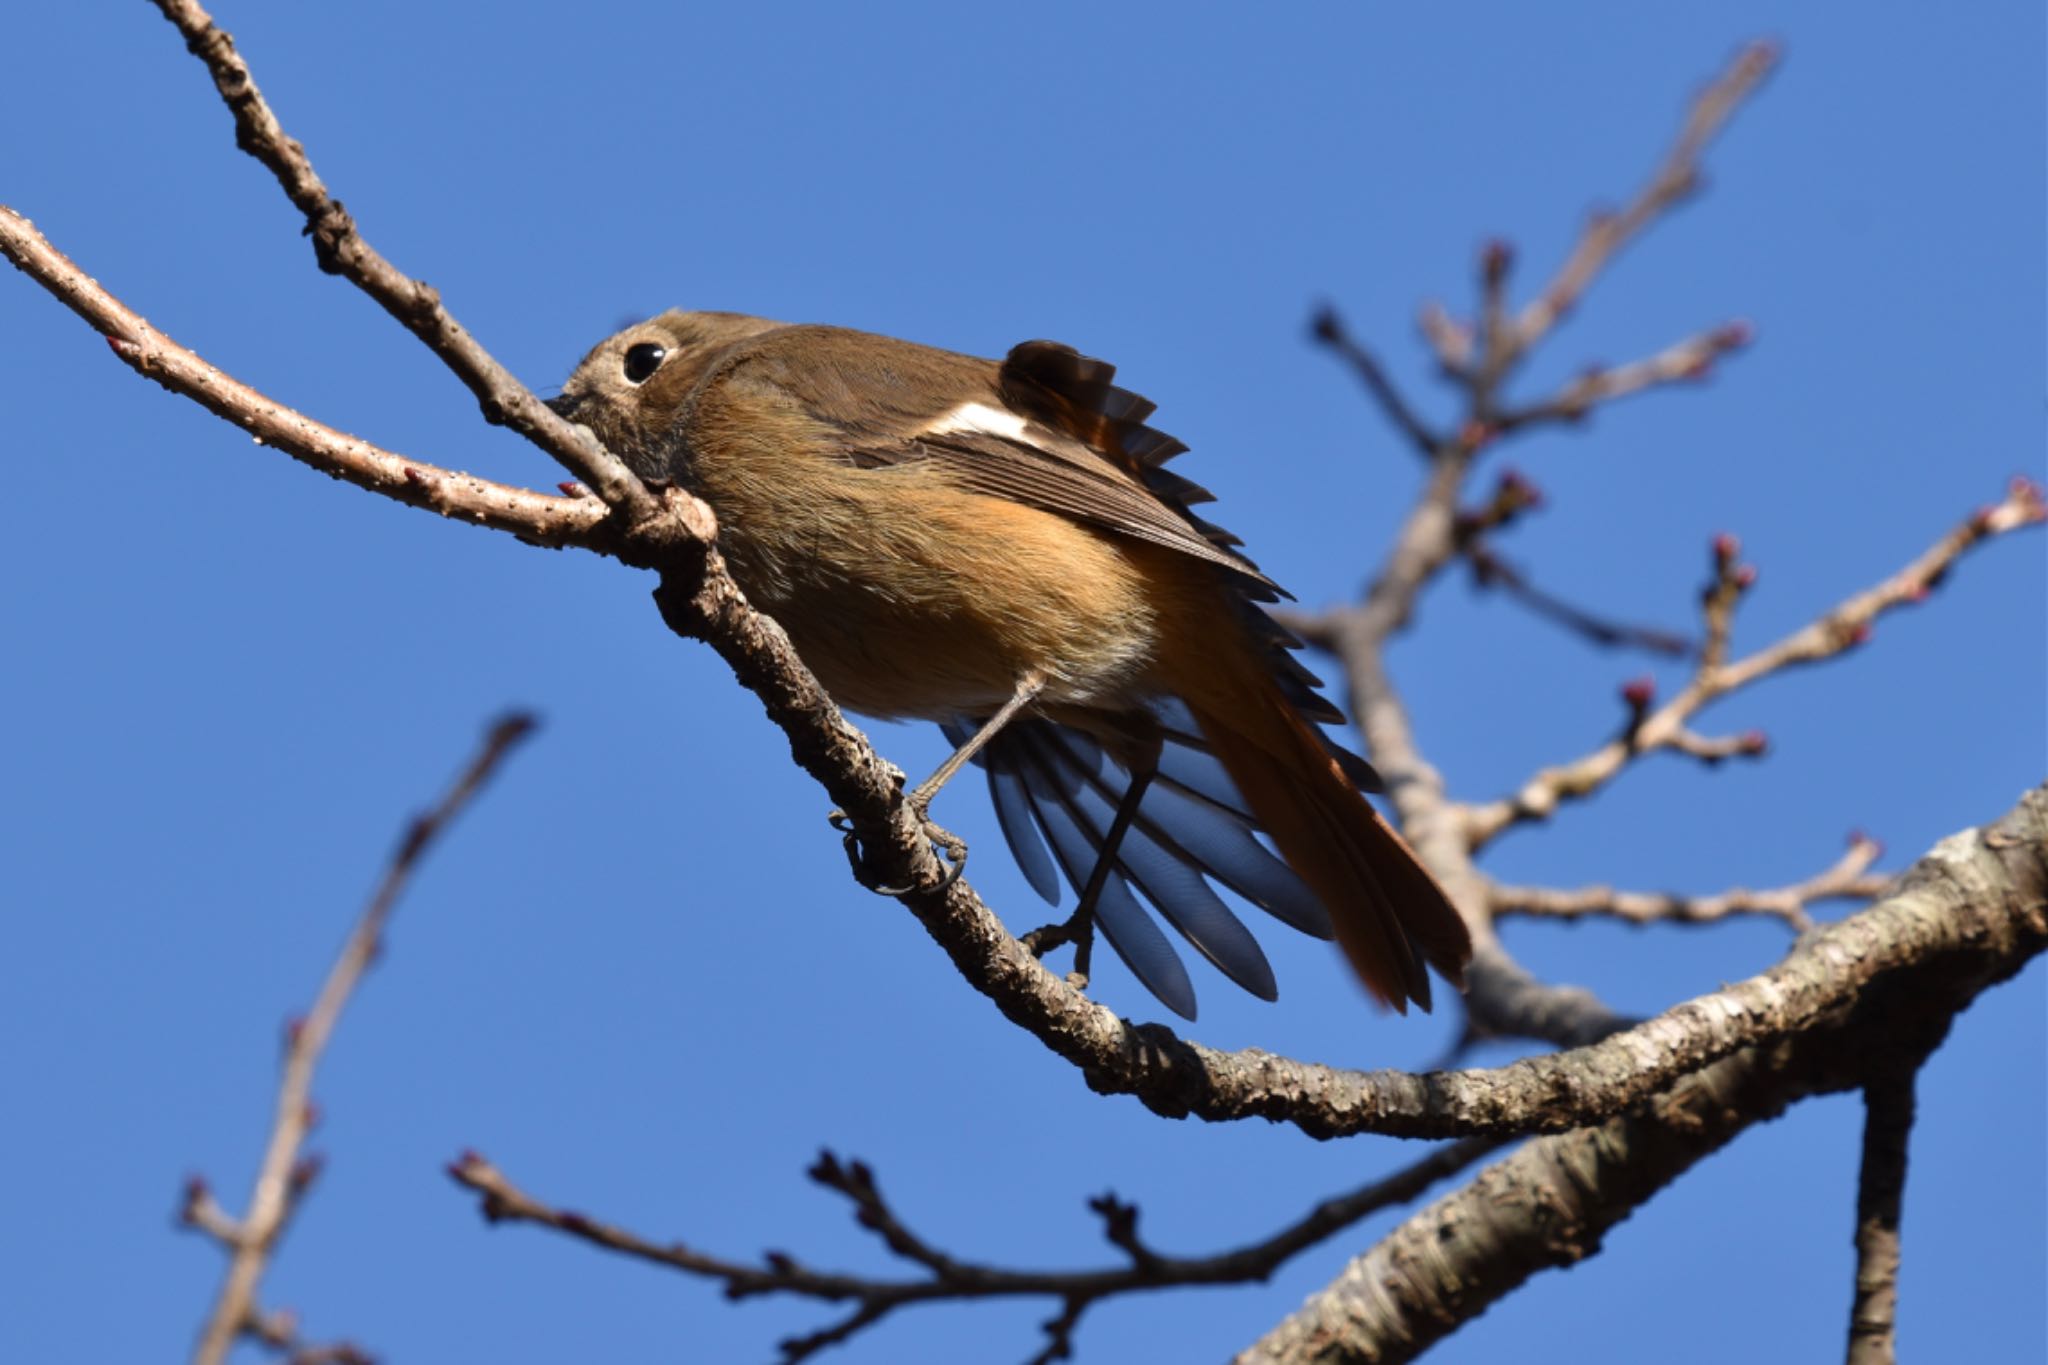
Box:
xmin=182 ymin=714 xmax=535 ymax=1365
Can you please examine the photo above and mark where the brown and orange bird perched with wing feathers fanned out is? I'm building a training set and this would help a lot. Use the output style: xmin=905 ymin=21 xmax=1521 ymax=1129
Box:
xmin=551 ymin=311 xmax=1470 ymax=1019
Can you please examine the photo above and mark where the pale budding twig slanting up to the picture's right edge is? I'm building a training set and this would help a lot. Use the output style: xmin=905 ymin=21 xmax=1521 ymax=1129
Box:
xmin=1464 ymin=479 xmax=2048 ymax=851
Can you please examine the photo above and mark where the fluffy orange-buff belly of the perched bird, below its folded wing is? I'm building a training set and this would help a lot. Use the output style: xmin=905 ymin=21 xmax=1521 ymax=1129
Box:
xmin=719 ymin=474 xmax=1159 ymax=720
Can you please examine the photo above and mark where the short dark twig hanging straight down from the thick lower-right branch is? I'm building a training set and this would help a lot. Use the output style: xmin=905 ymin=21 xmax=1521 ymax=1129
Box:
xmin=1847 ymin=1050 xmax=1925 ymax=1365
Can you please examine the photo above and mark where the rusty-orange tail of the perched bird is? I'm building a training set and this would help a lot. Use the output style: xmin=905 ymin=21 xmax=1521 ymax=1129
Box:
xmin=1182 ymin=649 xmax=1473 ymax=1013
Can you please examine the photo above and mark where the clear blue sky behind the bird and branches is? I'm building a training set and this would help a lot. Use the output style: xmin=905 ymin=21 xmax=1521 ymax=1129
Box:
xmin=0 ymin=0 xmax=2048 ymax=1365
